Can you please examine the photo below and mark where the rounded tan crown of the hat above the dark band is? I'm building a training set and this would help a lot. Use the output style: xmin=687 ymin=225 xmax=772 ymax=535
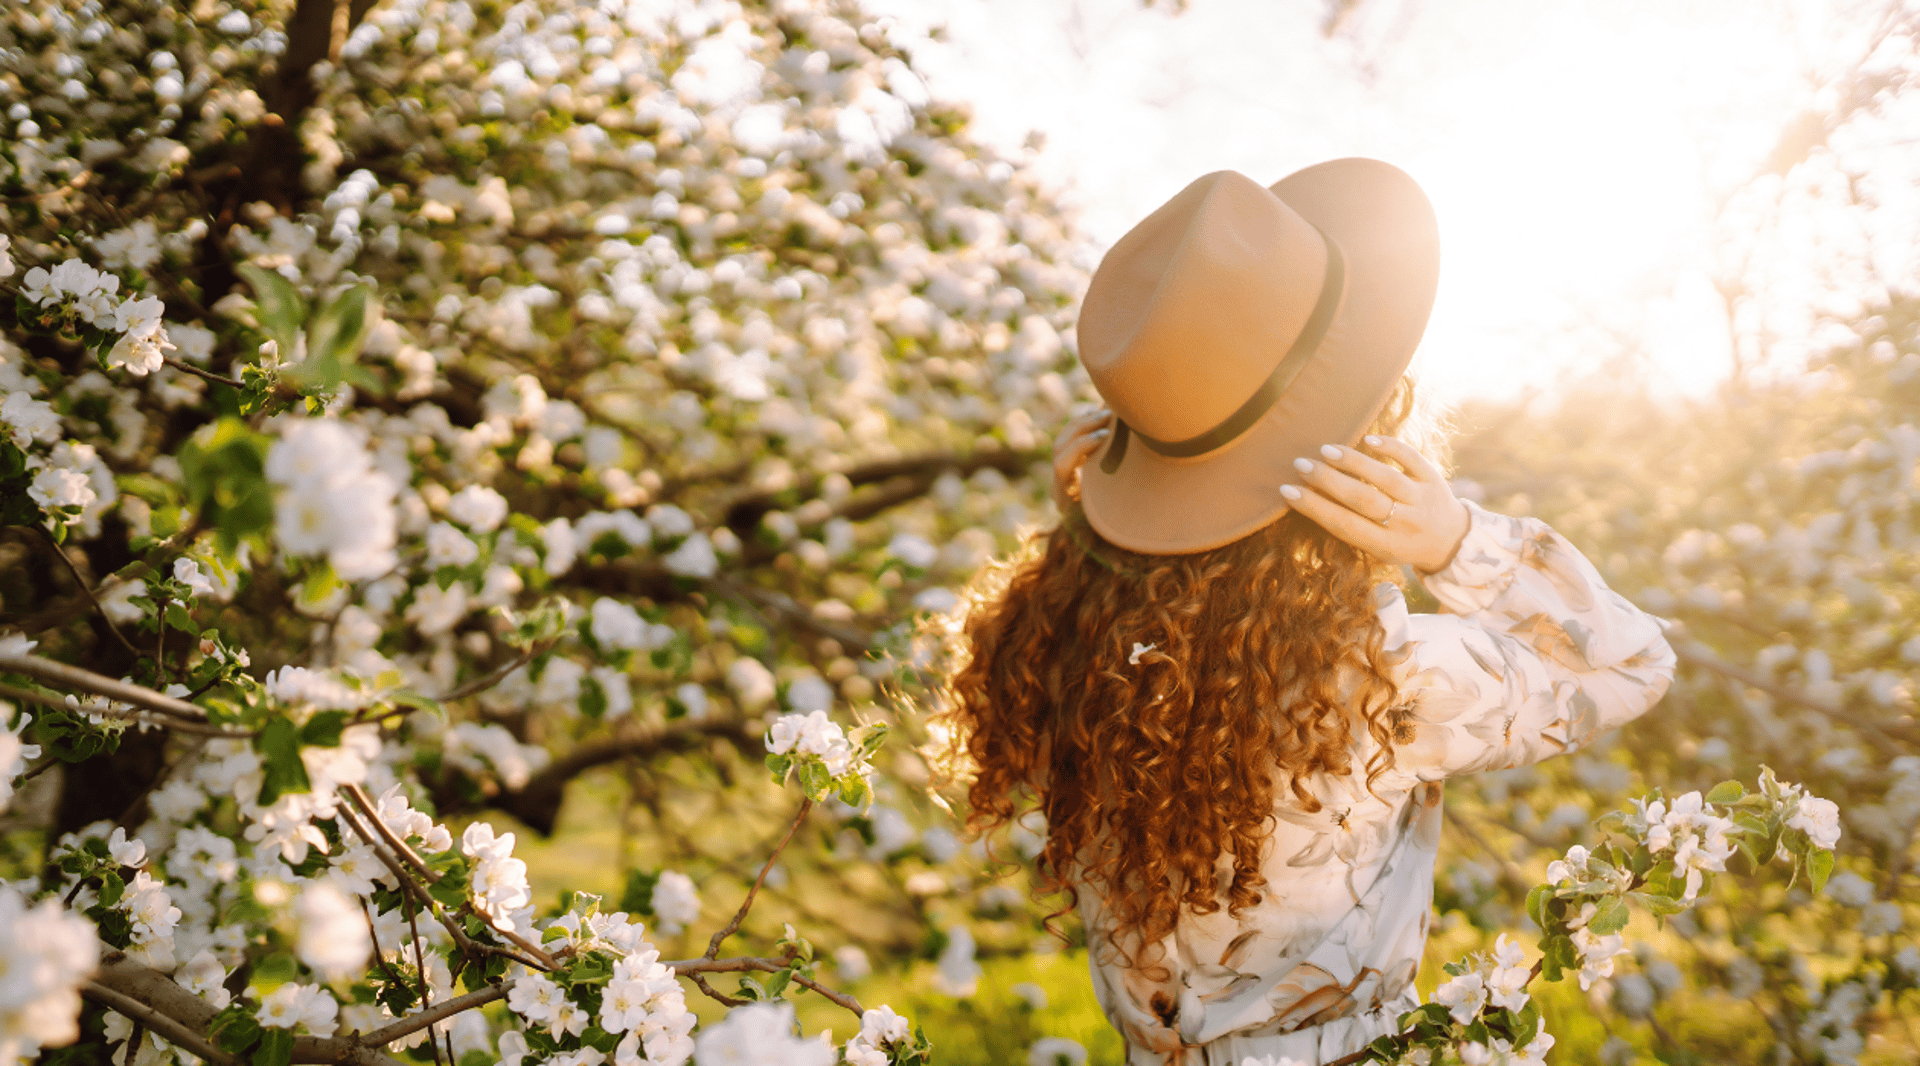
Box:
xmin=1077 ymin=171 xmax=1329 ymax=442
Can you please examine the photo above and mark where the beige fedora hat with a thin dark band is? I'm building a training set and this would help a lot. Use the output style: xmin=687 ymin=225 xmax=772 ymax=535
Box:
xmin=1077 ymin=159 xmax=1440 ymax=555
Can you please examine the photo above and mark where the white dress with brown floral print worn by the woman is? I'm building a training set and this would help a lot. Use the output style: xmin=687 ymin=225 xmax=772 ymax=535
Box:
xmin=1079 ymin=503 xmax=1674 ymax=1066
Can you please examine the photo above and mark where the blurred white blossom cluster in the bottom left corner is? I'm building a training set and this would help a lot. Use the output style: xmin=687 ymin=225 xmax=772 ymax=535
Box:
xmin=0 ymin=884 xmax=100 ymax=1062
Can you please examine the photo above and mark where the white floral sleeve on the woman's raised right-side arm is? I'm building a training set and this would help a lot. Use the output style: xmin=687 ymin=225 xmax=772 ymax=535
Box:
xmin=1380 ymin=503 xmax=1674 ymax=780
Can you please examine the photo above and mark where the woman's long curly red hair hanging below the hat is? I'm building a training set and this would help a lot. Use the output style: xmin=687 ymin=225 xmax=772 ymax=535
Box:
xmin=937 ymin=378 xmax=1442 ymax=943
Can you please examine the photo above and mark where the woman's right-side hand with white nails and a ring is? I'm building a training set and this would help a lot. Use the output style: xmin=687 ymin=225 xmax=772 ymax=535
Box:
xmin=1281 ymin=436 xmax=1469 ymax=574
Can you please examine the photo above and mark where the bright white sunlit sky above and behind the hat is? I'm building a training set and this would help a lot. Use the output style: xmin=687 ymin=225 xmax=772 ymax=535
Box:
xmin=868 ymin=0 xmax=1904 ymax=398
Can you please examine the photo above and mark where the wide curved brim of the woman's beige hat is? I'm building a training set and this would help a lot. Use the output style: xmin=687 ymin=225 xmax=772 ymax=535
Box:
xmin=1081 ymin=159 xmax=1440 ymax=555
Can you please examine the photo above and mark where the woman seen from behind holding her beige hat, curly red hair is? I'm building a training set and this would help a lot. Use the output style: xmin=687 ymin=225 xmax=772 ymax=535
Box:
xmin=947 ymin=159 xmax=1672 ymax=1066
